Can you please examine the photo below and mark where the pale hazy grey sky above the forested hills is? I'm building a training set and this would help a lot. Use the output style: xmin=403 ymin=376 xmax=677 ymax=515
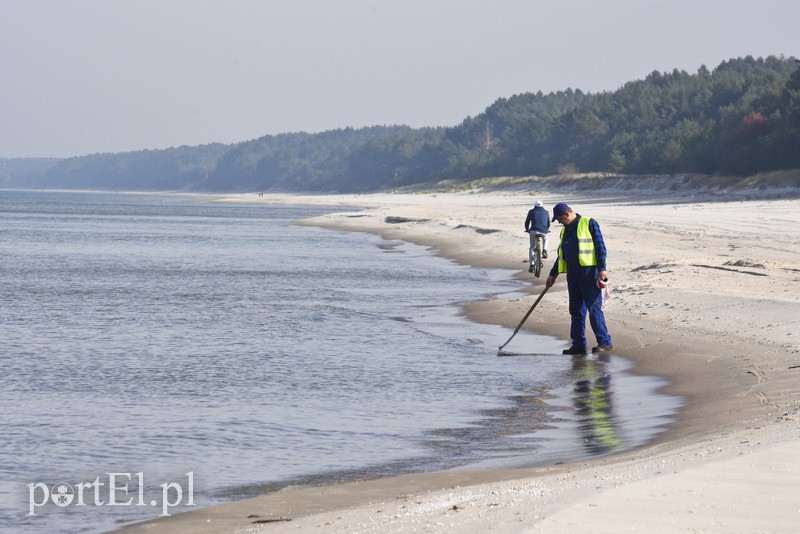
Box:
xmin=0 ymin=0 xmax=800 ymax=158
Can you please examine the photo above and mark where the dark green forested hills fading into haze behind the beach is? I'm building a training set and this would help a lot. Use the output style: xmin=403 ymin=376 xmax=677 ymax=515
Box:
xmin=0 ymin=56 xmax=800 ymax=192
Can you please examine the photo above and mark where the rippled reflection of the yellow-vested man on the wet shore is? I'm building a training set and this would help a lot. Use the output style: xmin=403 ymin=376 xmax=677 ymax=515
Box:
xmin=572 ymin=354 xmax=624 ymax=454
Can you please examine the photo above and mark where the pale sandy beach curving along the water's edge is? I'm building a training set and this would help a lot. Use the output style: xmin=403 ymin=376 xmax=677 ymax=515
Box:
xmin=123 ymin=179 xmax=800 ymax=534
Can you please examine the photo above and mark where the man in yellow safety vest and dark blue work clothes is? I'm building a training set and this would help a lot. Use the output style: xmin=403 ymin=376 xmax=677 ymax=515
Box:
xmin=545 ymin=202 xmax=613 ymax=354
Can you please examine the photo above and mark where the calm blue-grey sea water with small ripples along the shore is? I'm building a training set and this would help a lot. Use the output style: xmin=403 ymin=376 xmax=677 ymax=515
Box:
xmin=0 ymin=191 xmax=681 ymax=532
